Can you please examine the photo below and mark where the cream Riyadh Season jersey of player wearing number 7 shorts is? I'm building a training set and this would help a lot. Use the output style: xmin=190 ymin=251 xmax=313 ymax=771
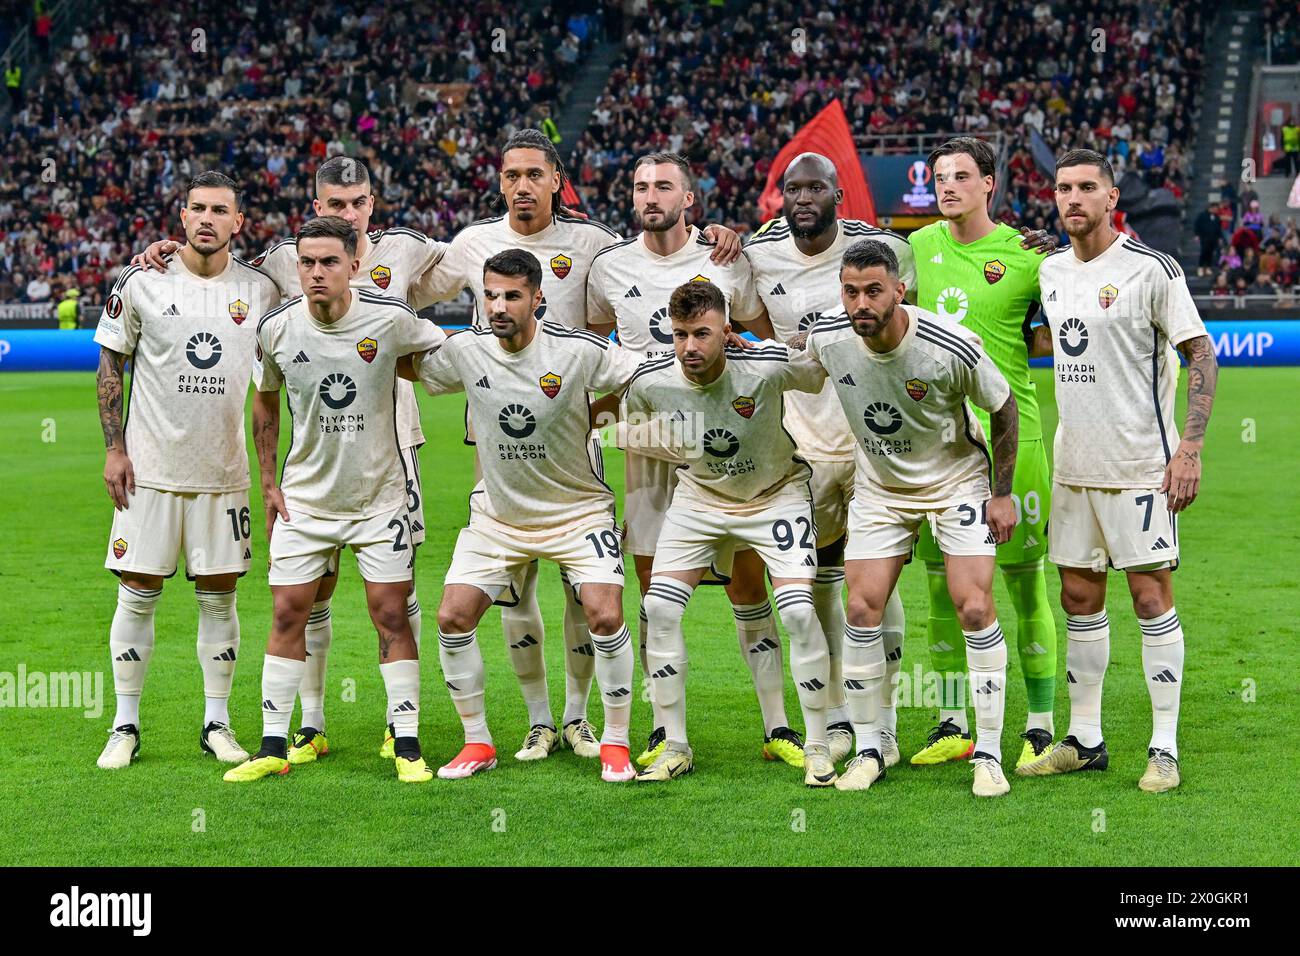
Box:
xmin=1039 ymin=235 xmax=1206 ymax=488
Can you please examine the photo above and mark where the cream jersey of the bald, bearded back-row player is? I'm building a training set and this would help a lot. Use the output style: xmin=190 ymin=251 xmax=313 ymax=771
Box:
xmin=745 ymin=216 xmax=917 ymax=462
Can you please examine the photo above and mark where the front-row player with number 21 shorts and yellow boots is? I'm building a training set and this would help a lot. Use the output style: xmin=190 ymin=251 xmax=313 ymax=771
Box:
xmin=225 ymin=216 xmax=446 ymax=783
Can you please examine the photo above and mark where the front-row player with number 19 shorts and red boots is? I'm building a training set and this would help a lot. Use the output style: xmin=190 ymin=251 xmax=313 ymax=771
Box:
xmin=413 ymin=248 xmax=640 ymax=782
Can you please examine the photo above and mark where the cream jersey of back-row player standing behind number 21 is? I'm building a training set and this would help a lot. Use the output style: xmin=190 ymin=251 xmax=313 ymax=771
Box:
xmin=252 ymin=226 xmax=447 ymax=447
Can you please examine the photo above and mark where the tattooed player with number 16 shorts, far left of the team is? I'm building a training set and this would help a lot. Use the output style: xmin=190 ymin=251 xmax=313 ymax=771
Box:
xmin=95 ymin=172 xmax=278 ymax=770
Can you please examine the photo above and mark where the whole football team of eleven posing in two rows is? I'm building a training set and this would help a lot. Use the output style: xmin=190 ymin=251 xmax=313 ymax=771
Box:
xmin=95 ymin=130 xmax=1217 ymax=796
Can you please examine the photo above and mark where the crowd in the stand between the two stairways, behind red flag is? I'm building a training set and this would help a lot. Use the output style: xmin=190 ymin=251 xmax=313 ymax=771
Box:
xmin=571 ymin=0 xmax=1208 ymax=239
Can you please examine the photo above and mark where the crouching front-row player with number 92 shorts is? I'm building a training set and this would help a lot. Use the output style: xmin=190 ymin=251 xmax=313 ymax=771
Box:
xmin=623 ymin=281 xmax=836 ymax=787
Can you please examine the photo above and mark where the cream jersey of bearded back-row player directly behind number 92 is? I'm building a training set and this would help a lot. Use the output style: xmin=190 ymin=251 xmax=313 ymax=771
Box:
xmin=586 ymin=226 xmax=763 ymax=359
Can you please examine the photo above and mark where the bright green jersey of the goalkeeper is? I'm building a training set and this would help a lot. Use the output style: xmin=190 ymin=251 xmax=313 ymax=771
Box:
xmin=907 ymin=220 xmax=1043 ymax=441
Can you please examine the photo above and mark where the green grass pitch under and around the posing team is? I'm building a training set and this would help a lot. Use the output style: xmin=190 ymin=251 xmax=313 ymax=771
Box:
xmin=0 ymin=369 xmax=1300 ymax=866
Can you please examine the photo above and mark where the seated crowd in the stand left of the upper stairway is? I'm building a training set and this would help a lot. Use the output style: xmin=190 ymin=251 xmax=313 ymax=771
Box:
xmin=0 ymin=0 xmax=594 ymax=302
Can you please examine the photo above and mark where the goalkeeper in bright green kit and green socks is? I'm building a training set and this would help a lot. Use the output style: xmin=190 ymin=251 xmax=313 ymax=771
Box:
xmin=909 ymin=137 xmax=1057 ymax=766
